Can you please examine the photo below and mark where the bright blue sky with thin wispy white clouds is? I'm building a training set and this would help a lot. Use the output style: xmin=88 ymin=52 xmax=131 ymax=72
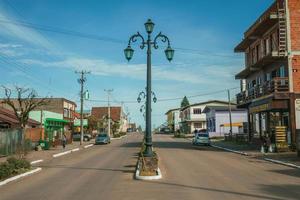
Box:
xmin=0 ymin=0 xmax=273 ymax=126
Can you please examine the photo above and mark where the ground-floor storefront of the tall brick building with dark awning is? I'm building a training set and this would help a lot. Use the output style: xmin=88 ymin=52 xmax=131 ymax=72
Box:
xmin=249 ymin=99 xmax=291 ymax=151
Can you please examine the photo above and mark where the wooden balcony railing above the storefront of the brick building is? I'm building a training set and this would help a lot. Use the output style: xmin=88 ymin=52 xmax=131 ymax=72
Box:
xmin=237 ymin=77 xmax=289 ymax=104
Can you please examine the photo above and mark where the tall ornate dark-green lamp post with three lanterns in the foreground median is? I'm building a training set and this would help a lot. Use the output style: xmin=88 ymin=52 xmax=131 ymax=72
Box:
xmin=124 ymin=19 xmax=174 ymax=157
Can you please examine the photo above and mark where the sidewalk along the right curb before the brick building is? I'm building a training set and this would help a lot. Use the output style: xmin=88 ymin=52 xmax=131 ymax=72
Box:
xmin=212 ymin=140 xmax=300 ymax=166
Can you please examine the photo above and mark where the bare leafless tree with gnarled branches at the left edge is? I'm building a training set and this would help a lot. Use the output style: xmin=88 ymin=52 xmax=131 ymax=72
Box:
xmin=2 ymin=86 xmax=48 ymax=129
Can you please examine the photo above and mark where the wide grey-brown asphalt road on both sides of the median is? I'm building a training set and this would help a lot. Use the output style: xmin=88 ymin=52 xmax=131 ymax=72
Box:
xmin=0 ymin=134 xmax=300 ymax=200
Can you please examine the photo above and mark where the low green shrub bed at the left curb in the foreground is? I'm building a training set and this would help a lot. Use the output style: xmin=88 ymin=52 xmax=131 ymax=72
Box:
xmin=0 ymin=157 xmax=31 ymax=180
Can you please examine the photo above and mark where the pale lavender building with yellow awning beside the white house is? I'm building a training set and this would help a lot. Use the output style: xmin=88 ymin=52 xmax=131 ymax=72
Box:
xmin=203 ymin=106 xmax=248 ymax=137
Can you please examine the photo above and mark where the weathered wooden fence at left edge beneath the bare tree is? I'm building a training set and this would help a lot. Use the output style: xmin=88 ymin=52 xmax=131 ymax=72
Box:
xmin=0 ymin=129 xmax=31 ymax=157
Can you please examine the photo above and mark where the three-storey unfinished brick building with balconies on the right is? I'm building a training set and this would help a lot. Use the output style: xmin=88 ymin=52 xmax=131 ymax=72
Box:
xmin=234 ymin=0 xmax=300 ymax=152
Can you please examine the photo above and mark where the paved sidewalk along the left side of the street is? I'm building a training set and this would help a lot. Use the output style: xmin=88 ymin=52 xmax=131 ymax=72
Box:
xmin=0 ymin=140 xmax=94 ymax=163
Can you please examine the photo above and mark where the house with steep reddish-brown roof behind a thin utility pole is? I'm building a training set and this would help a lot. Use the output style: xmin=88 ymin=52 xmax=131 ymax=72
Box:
xmin=91 ymin=106 xmax=129 ymax=132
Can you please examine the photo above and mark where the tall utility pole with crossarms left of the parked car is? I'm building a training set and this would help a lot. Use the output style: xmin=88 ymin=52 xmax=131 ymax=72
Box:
xmin=75 ymin=70 xmax=91 ymax=145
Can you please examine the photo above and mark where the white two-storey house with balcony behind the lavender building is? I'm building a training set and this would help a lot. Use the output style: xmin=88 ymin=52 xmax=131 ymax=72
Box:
xmin=180 ymin=100 xmax=228 ymax=133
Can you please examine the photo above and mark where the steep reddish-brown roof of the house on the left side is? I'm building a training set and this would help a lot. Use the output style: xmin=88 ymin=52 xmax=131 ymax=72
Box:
xmin=91 ymin=106 xmax=122 ymax=121
